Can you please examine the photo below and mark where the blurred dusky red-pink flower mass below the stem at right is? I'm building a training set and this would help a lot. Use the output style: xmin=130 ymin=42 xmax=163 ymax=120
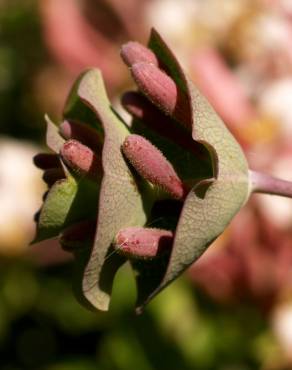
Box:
xmin=189 ymin=202 xmax=292 ymax=311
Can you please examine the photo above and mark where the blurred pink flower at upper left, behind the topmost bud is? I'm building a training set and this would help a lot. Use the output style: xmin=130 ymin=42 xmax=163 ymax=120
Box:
xmin=40 ymin=0 xmax=147 ymax=90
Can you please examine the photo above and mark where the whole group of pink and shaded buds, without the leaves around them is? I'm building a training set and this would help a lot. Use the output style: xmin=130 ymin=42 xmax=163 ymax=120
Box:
xmin=34 ymin=36 xmax=196 ymax=280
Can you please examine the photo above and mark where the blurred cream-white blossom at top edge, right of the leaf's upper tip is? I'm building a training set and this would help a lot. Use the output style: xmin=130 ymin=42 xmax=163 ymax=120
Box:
xmin=146 ymin=0 xmax=246 ymax=47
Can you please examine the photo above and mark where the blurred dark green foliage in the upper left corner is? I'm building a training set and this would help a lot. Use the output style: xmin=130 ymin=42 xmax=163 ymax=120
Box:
xmin=0 ymin=0 xmax=47 ymax=140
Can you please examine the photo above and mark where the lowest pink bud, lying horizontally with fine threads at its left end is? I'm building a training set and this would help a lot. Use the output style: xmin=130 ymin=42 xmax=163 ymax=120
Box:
xmin=115 ymin=227 xmax=173 ymax=259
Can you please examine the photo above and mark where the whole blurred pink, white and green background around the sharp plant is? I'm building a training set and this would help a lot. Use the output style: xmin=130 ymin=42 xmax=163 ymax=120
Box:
xmin=0 ymin=0 xmax=292 ymax=370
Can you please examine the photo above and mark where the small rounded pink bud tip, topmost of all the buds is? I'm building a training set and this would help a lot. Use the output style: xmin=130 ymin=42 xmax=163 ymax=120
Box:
xmin=121 ymin=41 xmax=158 ymax=67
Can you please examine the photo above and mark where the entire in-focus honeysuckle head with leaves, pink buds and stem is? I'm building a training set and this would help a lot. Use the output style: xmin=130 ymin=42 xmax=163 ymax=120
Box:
xmin=34 ymin=30 xmax=292 ymax=312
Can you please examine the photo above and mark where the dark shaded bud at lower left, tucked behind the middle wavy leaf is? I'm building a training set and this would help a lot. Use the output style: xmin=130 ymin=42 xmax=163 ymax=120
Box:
xmin=59 ymin=220 xmax=96 ymax=252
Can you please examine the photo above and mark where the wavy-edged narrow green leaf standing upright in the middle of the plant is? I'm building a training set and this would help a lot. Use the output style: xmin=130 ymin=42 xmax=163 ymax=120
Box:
xmin=65 ymin=69 xmax=146 ymax=310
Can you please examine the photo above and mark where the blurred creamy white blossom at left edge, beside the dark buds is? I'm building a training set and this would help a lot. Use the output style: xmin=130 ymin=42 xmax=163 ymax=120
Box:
xmin=0 ymin=137 xmax=45 ymax=255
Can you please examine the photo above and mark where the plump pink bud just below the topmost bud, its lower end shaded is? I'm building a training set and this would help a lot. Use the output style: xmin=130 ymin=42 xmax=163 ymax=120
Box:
xmin=131 ymin=63 xmax=191 ymax=128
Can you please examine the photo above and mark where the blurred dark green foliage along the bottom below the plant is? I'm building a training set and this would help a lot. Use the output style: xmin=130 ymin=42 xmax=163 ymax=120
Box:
xmin=0 ymin=259 xmax=274 ymax=370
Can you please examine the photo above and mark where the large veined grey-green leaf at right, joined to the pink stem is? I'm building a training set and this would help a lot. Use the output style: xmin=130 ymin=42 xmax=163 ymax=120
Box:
xmin=135 ymin=30 xmax=249 ymax=310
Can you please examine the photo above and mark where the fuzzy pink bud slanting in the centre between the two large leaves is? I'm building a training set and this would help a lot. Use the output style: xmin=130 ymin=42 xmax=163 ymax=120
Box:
xmin=122 ymin=135 xmax=185 ymax=199
